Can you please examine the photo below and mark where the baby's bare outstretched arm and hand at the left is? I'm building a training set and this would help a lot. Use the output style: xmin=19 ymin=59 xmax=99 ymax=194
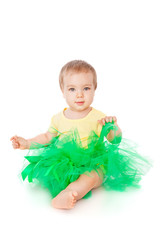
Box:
xmin=10 ymin=131 xmax=56 ymax=150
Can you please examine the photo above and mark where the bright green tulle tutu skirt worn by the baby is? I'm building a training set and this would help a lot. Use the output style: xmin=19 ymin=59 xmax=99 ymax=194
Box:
xmin=22 ymin=123 xmax=151 ymax=197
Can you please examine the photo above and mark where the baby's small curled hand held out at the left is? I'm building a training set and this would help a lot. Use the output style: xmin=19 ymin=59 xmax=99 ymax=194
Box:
xmin=10 ymin=136 xmax=29 ymax=150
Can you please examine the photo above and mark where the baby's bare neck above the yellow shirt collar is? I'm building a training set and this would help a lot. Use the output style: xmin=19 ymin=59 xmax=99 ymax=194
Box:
xmin=64 ymin=107 xmax=92 ymax=119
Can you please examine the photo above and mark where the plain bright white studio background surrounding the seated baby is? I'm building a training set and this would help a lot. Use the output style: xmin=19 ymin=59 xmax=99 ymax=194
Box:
xmin=0 ymin=0 xmax=160 ymax=240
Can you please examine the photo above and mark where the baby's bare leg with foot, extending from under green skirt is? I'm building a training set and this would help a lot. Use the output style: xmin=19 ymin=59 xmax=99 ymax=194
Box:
xmin=52 ymin=169 xmax=103 ymax=209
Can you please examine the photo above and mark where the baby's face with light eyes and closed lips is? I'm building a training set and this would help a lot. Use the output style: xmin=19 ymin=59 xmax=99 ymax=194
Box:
xmin=62 ymin=72 xmax=95 ymax=112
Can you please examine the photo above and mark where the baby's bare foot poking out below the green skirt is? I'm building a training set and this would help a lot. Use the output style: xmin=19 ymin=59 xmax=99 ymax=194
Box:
xmin=52 ymin=190 xmax=78 ymax=209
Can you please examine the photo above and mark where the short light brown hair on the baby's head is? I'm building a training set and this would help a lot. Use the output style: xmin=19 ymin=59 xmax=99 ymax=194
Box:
xmin=59 ymin=60 xmax=97 ymax=89
